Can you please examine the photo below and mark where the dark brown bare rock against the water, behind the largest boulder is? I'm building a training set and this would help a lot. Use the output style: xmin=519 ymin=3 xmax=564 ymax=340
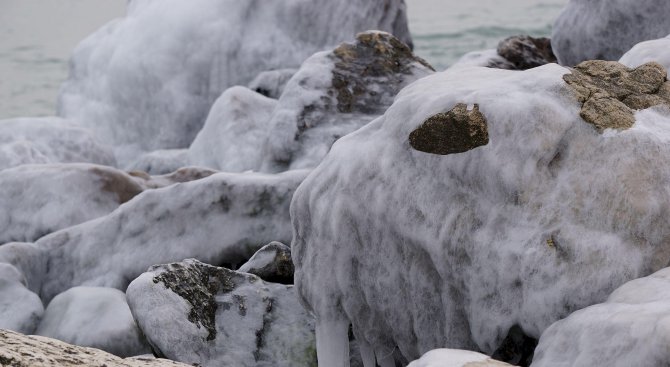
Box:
xmin=497 ymin=36 xmax=556 ymax=70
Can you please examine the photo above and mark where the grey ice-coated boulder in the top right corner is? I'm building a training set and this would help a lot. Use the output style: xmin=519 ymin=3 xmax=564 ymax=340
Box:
xmin=551 ymin=0 xmax=670 ymax=65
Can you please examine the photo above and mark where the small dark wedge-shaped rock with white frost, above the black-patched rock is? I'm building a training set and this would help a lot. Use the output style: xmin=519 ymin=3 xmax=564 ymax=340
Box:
xmin=238 ymin=242 xmax=294 ymax=284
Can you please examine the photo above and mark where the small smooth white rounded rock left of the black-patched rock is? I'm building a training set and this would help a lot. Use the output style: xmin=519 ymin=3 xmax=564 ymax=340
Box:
xmin=35 ymin=287 xmax=151 ymax=357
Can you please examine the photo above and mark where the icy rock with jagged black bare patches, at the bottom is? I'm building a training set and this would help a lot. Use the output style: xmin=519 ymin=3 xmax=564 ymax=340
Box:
xmin=127 ymin=259 xmax=316 ymax=367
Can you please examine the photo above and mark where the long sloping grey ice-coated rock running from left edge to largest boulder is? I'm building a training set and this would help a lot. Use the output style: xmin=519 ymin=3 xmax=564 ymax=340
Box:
xmin=0 ymin=171 xmax=307 ymax=302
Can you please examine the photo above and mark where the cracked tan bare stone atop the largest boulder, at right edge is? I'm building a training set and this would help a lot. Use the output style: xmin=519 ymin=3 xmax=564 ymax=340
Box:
xmin=563 ymin=60 xmax=670 ymax=132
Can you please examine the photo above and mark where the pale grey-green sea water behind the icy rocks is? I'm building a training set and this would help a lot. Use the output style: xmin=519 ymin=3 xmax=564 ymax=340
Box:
xmin=0 ymin=0 xmax=567 ymax=119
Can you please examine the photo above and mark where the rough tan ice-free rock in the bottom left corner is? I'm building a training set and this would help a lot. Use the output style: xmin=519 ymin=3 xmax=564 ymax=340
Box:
xmin=0 ymin=330 xmax=189 ymax=367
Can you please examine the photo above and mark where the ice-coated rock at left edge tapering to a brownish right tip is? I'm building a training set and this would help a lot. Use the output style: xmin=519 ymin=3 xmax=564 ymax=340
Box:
xmin=0 ymin=163 xmax=143 ymax=246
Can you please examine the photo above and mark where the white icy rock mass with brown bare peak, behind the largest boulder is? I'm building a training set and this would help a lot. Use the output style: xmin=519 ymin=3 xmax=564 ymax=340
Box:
xmin=190 ymin=31 xmax=432 ymax=172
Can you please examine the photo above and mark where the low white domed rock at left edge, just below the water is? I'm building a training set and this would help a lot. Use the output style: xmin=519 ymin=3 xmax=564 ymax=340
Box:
xmin=0 ymin=117 xmax=115 ymax=170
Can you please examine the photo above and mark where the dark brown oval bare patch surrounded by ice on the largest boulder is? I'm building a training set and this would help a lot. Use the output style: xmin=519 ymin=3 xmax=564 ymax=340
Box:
xmin=409 ymin=103 xmax=489 ymax=155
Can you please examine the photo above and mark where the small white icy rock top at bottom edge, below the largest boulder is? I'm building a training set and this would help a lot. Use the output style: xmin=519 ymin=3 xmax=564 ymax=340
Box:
xmin=407 ymin=349 xmax=511 ymax=367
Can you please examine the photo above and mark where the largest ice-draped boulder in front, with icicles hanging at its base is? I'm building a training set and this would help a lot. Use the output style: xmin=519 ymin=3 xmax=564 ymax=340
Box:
xmin=291 ymin=64 xmax=670 ymax=367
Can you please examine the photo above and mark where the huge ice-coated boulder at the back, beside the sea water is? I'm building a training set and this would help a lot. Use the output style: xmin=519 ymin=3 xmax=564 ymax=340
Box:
xmin=59 ymin=0 xmax=411 ymax=163
